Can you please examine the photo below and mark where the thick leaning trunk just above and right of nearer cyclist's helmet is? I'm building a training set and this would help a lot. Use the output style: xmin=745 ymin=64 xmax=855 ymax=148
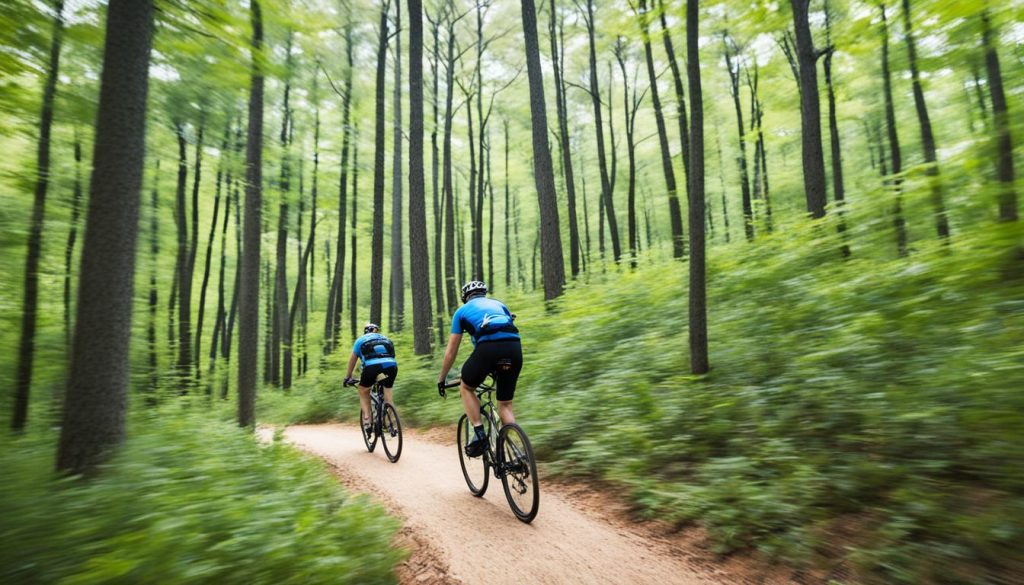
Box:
xmin=522 ymin=0 xmax=569 ymax=300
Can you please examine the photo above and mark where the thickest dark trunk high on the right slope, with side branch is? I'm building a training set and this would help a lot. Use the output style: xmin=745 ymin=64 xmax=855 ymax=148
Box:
xmin=790 ymin=0 xmax=825 ymax=218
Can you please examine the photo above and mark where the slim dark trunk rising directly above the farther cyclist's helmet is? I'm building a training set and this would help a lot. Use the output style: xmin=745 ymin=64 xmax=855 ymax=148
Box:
xmin=370 ymin=0 xmax=390 ymax=324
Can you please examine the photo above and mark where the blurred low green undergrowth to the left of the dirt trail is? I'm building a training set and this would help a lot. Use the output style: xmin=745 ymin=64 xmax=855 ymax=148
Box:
xmin=0 ymin=411 xmax=401 ymax=584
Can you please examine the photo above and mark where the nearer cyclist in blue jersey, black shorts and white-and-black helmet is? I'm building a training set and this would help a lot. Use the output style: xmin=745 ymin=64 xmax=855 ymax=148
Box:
xmin=437 ymin=281 xmax=522 ymax=457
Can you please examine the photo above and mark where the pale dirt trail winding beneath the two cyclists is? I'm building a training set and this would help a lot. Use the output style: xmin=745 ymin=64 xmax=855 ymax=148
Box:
xmin=285 ymin=424 xmax=742 ymax=585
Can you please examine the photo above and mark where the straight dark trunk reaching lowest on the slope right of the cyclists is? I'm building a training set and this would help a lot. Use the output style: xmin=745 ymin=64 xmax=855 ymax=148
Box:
xmin=686 ymin=0 xmax=709 ymax=374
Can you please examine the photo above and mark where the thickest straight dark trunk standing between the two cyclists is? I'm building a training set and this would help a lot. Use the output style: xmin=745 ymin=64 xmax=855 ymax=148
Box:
xmin=409 ymin=0 xmax=431 ymax=356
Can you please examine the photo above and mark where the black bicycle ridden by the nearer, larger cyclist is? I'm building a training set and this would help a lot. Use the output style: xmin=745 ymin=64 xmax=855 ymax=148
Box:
xmin=444 ymin=375 xmax=541 ymax=524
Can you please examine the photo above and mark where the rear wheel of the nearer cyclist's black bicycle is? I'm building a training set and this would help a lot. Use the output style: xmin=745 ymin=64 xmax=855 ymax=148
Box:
xmin=498 ymin=423 xmax=541 ymax=524
